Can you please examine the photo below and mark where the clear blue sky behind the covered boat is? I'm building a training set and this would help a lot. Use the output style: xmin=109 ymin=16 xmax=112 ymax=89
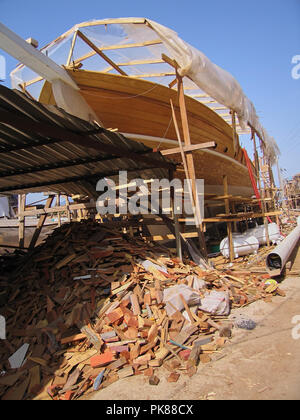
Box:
xmin=0 ymin=0 xmax=300 ymax=189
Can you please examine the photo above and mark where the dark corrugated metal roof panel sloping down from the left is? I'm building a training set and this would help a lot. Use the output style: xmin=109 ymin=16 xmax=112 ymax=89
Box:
xmin=0 ymin=85 xmax=174 ymax=196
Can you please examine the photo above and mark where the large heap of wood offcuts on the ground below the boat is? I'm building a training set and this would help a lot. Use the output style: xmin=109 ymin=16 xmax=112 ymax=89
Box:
xmin=0 ymin=221 xmax=284 ymax=400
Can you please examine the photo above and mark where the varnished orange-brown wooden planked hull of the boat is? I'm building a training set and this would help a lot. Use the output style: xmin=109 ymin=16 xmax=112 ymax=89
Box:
xmin=40 ymin=70 xmax=253 ymax=195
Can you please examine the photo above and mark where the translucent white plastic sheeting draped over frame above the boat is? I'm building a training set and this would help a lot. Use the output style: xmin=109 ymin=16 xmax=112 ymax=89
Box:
xmin=11 ymin=18 xmax=280 ymax=164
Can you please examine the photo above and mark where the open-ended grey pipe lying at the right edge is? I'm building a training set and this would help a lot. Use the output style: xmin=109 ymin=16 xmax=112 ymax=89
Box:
xmin=266 ymin=225 xmax=300 ymax=276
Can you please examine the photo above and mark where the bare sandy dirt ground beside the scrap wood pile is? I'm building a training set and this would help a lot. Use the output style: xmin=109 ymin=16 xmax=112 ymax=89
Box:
xmin=89 ymin=277 xmax=300 ymax=400
